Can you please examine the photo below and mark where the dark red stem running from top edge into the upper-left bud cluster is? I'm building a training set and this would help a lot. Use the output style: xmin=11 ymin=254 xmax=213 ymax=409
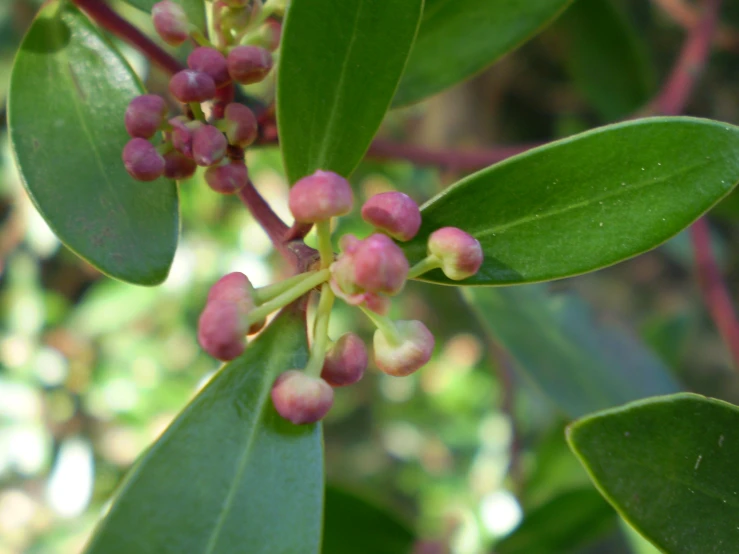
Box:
xmin=72 ymin=0 xmax=184 ymax=74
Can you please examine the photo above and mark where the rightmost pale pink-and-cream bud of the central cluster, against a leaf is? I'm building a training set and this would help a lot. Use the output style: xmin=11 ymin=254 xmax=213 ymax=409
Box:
xmin=428 ymin=227 xmax=483 ymax=281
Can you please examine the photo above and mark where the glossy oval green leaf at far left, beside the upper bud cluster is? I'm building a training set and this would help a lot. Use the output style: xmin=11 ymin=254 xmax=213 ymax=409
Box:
xmin=8 ymin=2 xmax=179 ymax=285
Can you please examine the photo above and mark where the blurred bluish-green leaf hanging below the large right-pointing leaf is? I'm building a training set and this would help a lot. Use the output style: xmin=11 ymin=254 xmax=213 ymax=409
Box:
xmin=464 ymin=285 xmax=680 ymax=418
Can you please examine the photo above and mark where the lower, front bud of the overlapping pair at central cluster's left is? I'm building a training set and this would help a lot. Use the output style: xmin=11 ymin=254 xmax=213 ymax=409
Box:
xmin=198 ymin=300 xmax=246 ymax=361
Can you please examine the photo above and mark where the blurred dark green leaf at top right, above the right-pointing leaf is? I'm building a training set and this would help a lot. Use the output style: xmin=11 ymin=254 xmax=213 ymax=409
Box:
xmin=553 ymin=0 xmax=655 ymax=120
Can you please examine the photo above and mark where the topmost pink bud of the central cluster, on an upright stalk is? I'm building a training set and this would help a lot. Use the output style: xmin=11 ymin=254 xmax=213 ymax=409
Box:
xmin=288 ymin=169 xmax=354 ymax=223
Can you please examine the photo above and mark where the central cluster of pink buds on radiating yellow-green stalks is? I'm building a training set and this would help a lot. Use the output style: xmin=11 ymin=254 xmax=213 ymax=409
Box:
xmin=199 ymin=170 xmax=483 ymax=424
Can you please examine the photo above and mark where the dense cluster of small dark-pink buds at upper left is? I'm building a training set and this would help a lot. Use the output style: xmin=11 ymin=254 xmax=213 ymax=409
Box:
xmin=122 ymin=0 xmax=284 ymax=190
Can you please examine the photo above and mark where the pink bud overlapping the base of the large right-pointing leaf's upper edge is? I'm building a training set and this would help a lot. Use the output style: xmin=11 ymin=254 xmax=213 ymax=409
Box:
xmin=362 ymin=192 xmax=421 ymax=241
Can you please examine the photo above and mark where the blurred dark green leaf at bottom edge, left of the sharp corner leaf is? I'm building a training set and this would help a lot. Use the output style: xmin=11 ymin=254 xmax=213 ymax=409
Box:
xmin=495 ymin=488 xmax=617 ymax=554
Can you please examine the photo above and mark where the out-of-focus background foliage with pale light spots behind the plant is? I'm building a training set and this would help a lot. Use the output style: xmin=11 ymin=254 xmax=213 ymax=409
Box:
xmin=0 ymin=0 xmax=739 ymax=554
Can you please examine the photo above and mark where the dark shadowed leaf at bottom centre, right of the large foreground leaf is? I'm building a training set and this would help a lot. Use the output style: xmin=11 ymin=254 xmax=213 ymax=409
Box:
xmin=322 ymin=486 xmax=414 ymax=554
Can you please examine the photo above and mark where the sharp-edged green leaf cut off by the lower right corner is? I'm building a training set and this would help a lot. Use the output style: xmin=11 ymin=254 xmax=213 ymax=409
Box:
xmin=567 ymin=394 xmax=739 ymax=554
